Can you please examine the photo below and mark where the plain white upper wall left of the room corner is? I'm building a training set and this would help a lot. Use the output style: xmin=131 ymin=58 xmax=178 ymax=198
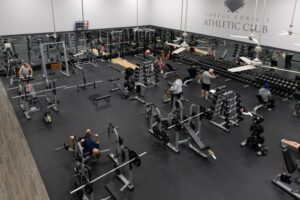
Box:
xmin=0 ymin=0 xmax=150 ymax=35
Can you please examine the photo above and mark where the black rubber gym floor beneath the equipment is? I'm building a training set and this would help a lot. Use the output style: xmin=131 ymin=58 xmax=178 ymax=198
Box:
xmin=2 ymin=57 xmax=300 ymax=200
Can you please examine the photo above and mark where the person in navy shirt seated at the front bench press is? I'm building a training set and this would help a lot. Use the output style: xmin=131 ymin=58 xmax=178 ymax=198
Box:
xmin=65 ymin=129 xmax=100 ymax=159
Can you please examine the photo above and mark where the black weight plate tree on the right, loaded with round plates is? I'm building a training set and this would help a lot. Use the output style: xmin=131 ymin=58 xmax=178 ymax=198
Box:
xmin=241 ymin=113 xmax=268 ymax=156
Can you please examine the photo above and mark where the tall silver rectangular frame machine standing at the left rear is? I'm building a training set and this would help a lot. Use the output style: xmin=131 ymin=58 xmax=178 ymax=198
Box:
xmin=40 ymin=41 xmax=70 ymax=80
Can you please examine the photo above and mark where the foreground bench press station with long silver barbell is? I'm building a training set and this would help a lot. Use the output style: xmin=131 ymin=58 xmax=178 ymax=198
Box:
xmin=54 ymin=123 xmax=147 ymax=200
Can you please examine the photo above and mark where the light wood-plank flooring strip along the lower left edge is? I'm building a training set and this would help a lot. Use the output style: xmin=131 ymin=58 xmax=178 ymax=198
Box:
xmin=0 ymin=80 xmax=49 ymax=200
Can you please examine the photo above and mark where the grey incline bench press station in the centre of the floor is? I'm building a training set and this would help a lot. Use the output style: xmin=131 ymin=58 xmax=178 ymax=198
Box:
xmin=146 ymin=100 xmax=216 ymax=159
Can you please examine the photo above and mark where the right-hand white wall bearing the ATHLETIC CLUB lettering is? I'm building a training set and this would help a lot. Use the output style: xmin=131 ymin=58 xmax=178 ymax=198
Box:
xmin=150 ymin=0 xmax=300 ymax=51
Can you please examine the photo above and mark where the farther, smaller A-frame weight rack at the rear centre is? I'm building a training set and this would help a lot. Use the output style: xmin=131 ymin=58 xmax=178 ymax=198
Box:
xmin=134 ymin=61 xmax=158 ymax=87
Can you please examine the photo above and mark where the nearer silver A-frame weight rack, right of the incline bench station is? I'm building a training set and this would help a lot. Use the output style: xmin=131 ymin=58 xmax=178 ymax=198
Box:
xmin=209 ymin=91 xmax=240 ymax=132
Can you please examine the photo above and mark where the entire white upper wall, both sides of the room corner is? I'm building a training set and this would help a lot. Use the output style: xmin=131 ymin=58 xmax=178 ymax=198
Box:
xmin=0 ymin=0 xmax=300 ymax=51
